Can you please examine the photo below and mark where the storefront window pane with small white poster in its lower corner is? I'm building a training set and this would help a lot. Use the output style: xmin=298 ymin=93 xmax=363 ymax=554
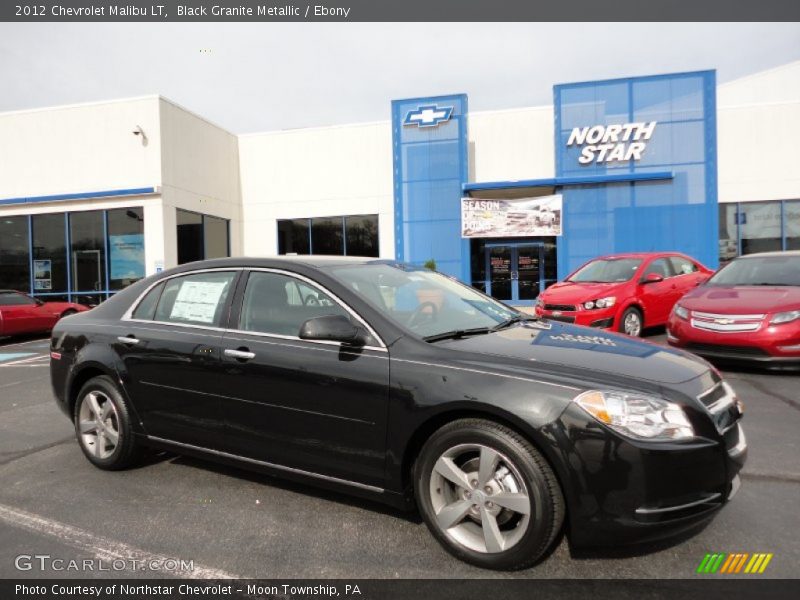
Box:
xmin=31 ymin=213 xmax=67 ymax=294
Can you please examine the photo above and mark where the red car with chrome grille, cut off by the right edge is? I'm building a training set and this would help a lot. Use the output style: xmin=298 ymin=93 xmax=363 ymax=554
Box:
xmin=667 ymin=251 xmax=800 ymax=367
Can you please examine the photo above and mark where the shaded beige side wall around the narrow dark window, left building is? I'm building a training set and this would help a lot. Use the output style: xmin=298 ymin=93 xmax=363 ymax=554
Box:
xmin=160 ymin=98 xmax=242 ymax=260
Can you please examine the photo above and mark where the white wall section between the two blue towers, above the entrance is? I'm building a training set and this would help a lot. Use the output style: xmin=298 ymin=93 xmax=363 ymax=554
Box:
xmin=467 ymin=106 xmax=556 ymax=182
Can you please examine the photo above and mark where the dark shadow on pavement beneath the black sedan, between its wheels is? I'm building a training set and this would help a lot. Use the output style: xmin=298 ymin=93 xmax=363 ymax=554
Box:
xmin=151 ymin=452 xmax=423 ymax=524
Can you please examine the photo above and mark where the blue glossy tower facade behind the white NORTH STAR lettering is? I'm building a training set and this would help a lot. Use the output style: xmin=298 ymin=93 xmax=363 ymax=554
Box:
xmin=554 ymin=71 xmax=719 ymax=278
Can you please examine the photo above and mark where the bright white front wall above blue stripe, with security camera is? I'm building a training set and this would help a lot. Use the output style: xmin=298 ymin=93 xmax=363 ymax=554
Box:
xmin=0 ymin=96 xmax=161 ymax=198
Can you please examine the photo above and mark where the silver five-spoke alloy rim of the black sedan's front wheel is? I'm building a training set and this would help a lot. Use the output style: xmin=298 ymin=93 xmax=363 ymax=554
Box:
xmin=430 ymin=444 xmax=531 ymax=554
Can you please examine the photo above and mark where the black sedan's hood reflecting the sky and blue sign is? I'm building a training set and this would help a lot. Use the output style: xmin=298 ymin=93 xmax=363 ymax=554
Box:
xmin=440 ymin=320 xmax=710 ymax=385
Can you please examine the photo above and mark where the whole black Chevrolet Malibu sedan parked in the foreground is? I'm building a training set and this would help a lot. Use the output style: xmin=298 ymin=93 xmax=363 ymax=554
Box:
xmin=51 ymin=256 xmax=747 ymax=569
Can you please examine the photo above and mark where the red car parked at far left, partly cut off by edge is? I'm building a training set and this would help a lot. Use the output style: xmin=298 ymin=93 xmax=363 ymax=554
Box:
xmin=0 ymin=290 xmax=89 ymax=336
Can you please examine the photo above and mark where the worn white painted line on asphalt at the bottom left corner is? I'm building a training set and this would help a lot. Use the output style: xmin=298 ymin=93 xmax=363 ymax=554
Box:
xmin=0 ymin=504 xmax=240 ymax=579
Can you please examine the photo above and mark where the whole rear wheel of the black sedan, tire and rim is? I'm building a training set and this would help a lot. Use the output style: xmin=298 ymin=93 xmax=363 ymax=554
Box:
xmin=74 ymin=375 xmax=141 ymax=471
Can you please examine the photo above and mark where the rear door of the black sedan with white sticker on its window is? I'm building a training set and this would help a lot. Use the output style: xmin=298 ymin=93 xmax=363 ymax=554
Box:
xmin=113 ymin=271 xmax=237 ymax=448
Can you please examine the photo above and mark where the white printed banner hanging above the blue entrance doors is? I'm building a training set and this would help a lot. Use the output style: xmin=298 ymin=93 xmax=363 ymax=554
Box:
xmin=461 ymin=194 xmax=563 ymax=238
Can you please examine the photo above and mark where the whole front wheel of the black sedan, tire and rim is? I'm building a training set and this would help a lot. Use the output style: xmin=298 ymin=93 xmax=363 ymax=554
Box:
xmin=413 ymin=419 xmax=565 ymax=570
